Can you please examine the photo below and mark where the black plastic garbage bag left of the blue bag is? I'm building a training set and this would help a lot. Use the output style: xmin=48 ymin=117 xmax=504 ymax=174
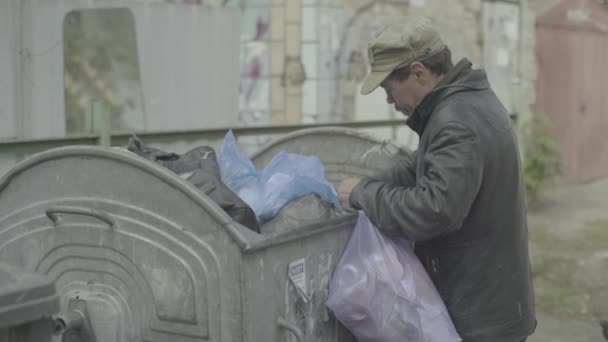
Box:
xmin=127 ymin=136 xmax=260 ymax=233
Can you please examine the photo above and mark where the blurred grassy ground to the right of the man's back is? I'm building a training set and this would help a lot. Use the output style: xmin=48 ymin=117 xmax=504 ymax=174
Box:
xmin=528 ymin=179 xmax=608 ymax=342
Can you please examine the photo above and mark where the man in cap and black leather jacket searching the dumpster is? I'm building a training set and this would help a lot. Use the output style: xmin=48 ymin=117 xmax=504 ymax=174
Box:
xmin=338 ymin=18 xmax=536 ymax=342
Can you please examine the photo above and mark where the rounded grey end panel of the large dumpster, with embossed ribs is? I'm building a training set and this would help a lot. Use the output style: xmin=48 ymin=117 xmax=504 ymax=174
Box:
xmin=0 ymin=149 xmax=247 ymax=342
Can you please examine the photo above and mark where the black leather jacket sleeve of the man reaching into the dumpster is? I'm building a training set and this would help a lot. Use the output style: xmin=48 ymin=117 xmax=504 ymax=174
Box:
xmin=350 ymin=122 xmax=483 ymax=242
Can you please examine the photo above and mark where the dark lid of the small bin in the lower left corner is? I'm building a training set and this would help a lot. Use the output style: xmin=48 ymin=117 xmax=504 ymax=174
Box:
xmin=0 ymin=263 xmax=59 ymax=329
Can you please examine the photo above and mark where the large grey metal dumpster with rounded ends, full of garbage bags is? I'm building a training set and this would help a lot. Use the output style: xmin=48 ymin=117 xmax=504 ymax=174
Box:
xmin=0 ymin=129 xmax=404 ymax=342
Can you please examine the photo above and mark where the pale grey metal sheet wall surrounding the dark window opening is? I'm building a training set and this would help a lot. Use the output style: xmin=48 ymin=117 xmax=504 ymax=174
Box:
xmin=11 ymin=0 xmax=240 ymax=138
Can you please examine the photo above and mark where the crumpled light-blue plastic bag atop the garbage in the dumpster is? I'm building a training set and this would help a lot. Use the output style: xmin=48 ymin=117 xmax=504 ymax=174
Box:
xmin=218 ymin=131 xmax=340 ymax=224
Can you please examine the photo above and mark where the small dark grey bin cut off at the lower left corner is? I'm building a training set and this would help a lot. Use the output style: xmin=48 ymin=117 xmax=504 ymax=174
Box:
xmin=0 ymin=263 xmax=59 ymax=342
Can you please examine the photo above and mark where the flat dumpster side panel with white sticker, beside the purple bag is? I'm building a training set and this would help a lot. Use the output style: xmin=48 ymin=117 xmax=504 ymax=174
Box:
xmin=243 ymin=220 xmax=355 ymax=342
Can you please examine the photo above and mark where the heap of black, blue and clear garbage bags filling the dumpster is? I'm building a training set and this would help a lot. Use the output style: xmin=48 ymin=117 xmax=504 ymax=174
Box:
xmin=127 ymin=132 xmax=339 ymax=233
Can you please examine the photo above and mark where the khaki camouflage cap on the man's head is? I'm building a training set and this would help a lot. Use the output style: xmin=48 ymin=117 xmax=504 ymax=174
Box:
xmin=361 ymin=16 xmax=445 ymax=95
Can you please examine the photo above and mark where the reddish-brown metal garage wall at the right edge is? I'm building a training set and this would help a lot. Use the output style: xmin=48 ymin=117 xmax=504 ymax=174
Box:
xmin=536 ymin=0 xmax=608 ymax=182
